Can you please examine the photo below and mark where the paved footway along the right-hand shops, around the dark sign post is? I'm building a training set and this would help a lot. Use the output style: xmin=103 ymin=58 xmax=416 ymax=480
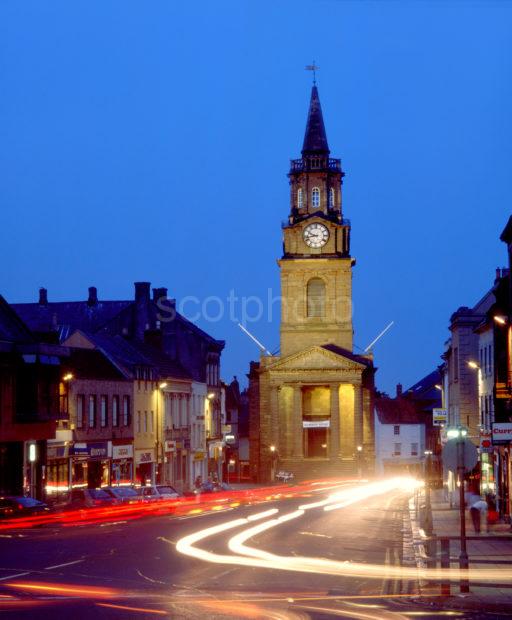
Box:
xmin=410 ymin=489 xmax=512 ymax=618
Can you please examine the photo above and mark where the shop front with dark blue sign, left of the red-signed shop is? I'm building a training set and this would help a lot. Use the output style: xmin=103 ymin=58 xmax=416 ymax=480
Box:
xmin=71 ymin=441 xmax=112 ymax=489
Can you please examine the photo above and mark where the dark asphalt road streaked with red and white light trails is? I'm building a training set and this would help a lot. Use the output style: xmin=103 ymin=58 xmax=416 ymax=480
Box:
xmin=0 ymin=485 xmax=505 ymax=620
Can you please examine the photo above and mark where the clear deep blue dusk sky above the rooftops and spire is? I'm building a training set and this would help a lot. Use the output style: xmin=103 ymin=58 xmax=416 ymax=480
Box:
xmin=0 ymin=0 xmax=512 ymax=391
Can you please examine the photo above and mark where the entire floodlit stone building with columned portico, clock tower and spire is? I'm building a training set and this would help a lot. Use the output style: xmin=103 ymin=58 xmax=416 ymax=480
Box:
xmin=249 ymin=84 xmax=375 ymax=482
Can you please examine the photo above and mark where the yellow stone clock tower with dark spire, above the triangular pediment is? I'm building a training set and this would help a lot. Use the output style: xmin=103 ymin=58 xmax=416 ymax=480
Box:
xmin=279 ymin=85 xmax=354 ymax=355
